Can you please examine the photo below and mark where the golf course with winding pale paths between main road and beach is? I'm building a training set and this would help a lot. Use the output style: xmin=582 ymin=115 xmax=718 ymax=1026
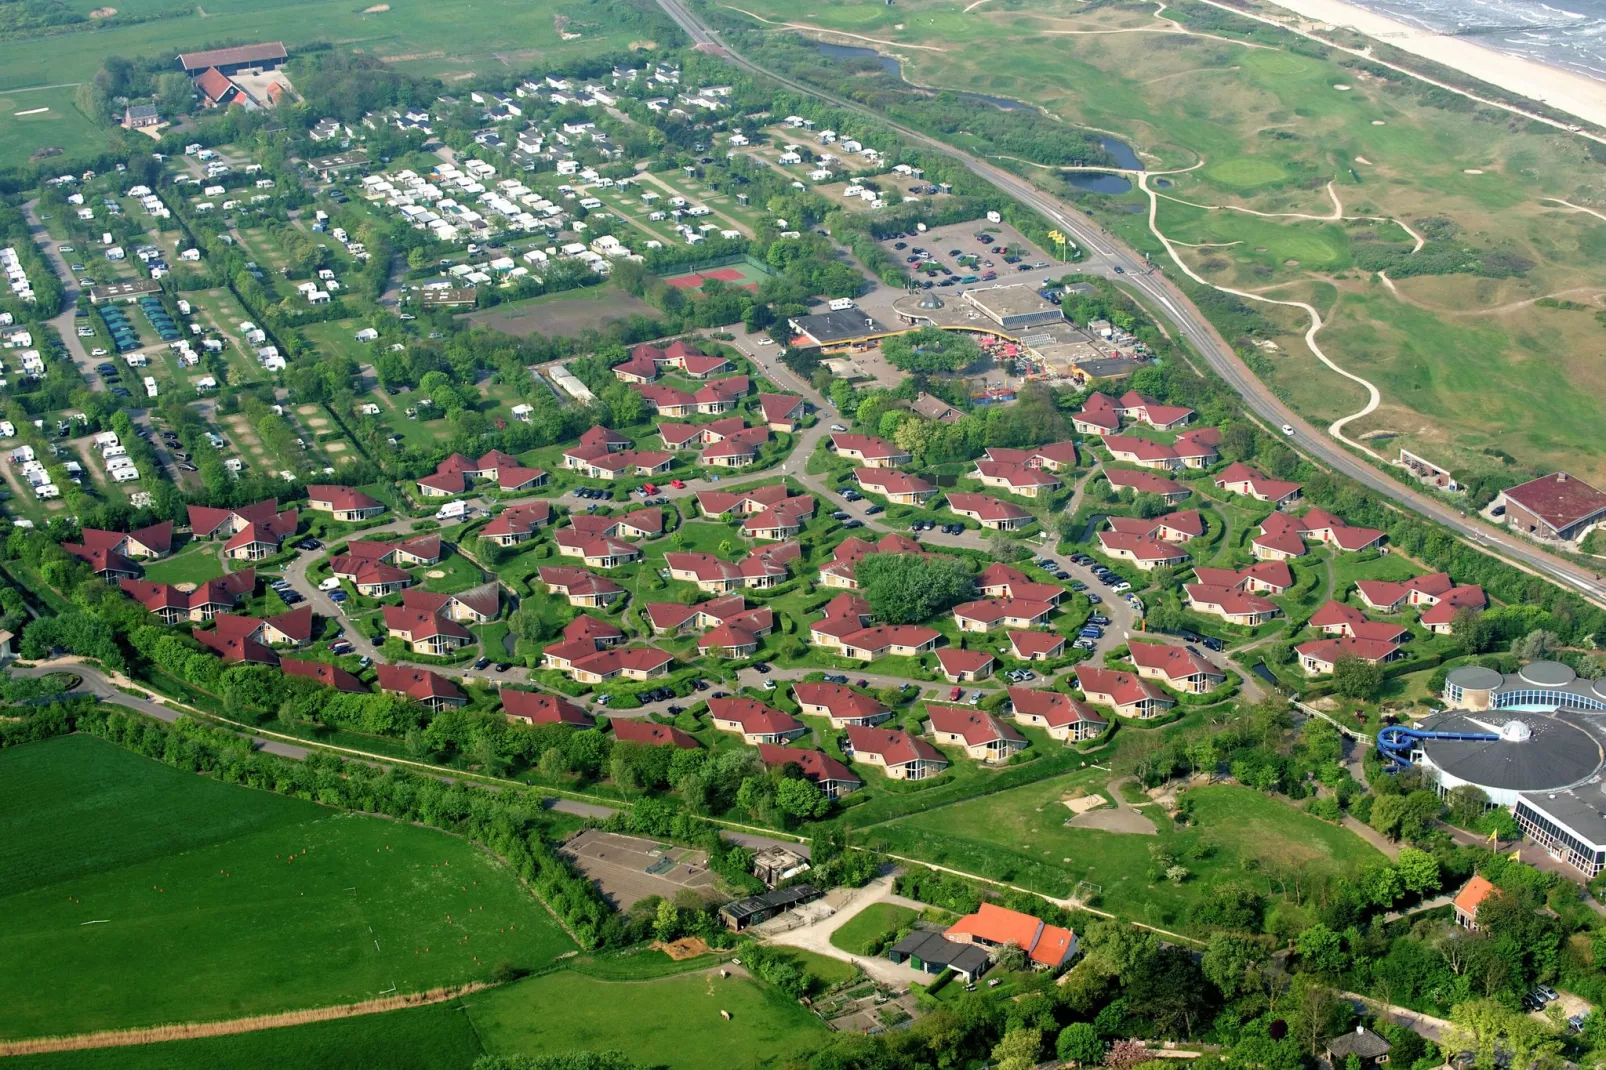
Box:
xmin=722 ymin=0 xmax=1606 ymax=480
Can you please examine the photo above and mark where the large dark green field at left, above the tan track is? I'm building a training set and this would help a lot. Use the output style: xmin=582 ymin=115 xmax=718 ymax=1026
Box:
xmin=0 ymin=736 xmax=570 ymax=1036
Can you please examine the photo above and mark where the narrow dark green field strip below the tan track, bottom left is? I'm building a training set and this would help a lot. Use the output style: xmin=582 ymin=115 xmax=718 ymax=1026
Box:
xmin=6 ymin=1001 xmax=483 ymax=1070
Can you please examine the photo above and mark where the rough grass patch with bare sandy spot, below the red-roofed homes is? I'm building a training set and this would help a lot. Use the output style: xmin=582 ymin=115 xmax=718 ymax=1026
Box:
xmin=869 ymin=770 xmax=1381 ymax=927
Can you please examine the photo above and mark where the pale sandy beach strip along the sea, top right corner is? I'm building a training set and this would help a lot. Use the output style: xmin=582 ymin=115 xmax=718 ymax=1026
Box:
xmin=1270 ymin=0 xmax=1606 ymax=127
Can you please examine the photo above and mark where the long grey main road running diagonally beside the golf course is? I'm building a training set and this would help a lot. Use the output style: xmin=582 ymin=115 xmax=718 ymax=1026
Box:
xmin=657 ymin=0 xmax=1606 ymax=606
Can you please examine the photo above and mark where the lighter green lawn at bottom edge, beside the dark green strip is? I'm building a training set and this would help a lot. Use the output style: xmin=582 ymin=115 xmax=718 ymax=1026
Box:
xmin=463 ymin=970 xmax=829 ymax=1070
